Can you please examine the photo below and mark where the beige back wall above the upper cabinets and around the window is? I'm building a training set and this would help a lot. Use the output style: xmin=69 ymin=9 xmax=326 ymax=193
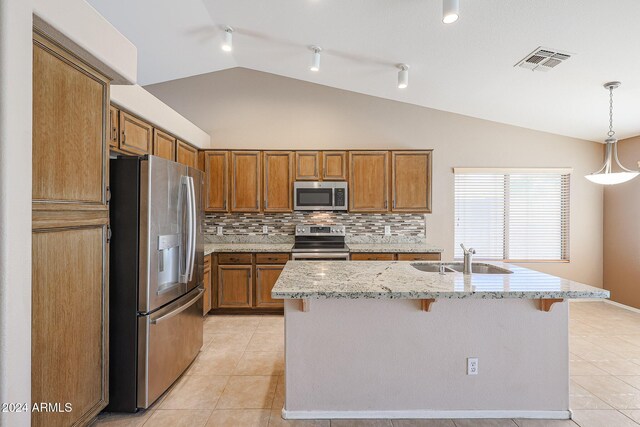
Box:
xmin=146 ymin=68 xmax=603 ymax=286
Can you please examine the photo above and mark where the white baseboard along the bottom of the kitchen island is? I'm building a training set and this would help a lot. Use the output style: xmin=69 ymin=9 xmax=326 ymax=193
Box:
xmin=282 ymin=408 xmax=571 ymax=420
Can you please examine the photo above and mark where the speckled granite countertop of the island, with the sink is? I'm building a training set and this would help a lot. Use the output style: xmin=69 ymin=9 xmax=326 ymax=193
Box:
xmin=271 ymin=261 xmax=609 ymax=299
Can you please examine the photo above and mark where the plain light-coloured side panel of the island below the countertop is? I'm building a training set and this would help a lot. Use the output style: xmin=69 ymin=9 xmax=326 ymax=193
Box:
xmin=284 ymin=299 xmax=569 ymax=418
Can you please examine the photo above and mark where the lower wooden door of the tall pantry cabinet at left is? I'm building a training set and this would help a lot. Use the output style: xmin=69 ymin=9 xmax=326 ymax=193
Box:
xmin=31 ymin=224 xmax=108 ymax=426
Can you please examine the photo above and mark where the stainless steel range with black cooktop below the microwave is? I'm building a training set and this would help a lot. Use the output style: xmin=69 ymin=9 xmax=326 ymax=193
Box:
xmin=291 ymin=225 xmax=349 ymax=261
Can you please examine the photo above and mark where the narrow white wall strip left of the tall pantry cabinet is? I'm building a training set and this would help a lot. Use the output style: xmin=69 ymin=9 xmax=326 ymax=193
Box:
xmin=0 ymin=0 xmax=32 ymax=427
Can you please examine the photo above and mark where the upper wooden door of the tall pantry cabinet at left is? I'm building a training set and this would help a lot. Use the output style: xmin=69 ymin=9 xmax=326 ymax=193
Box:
xmin=32 ymin=33 xmax=109 ymax=209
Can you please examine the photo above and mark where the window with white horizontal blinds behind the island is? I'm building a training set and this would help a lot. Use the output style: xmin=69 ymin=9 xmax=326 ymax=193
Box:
xmin=454 ymin=168 xmax=571 ymax=261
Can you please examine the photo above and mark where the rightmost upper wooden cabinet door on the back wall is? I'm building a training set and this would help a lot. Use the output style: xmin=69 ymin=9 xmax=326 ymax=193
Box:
xmin=391 ymin=151 xmax=431 ymax=213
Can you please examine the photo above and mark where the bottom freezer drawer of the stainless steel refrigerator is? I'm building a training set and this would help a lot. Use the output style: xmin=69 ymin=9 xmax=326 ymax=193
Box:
xmin=137 ymin=288 xmax=204 ymax=408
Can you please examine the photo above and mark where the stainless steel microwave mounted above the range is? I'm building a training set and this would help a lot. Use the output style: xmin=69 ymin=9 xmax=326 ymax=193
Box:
xmin=293 ymin=181 xmax=349 ymax=211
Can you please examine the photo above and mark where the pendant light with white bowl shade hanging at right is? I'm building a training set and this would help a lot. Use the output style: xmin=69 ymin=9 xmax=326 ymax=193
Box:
xmin=585 ymin=82 xmax=640 ymax=185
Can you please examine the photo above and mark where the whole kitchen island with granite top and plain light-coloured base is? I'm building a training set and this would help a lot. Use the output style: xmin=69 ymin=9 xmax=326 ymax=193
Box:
xmin=272 ymin=261 xmax=609 ymax=419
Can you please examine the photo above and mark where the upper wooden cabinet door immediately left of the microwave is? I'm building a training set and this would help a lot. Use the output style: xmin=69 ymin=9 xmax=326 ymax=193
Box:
xmin=263 ymin=151 xmax=293 ymax=212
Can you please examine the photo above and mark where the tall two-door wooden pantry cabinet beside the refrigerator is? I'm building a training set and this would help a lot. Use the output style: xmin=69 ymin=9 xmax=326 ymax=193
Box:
xmin=31 ymin=32 xmax=109 ymax=427
